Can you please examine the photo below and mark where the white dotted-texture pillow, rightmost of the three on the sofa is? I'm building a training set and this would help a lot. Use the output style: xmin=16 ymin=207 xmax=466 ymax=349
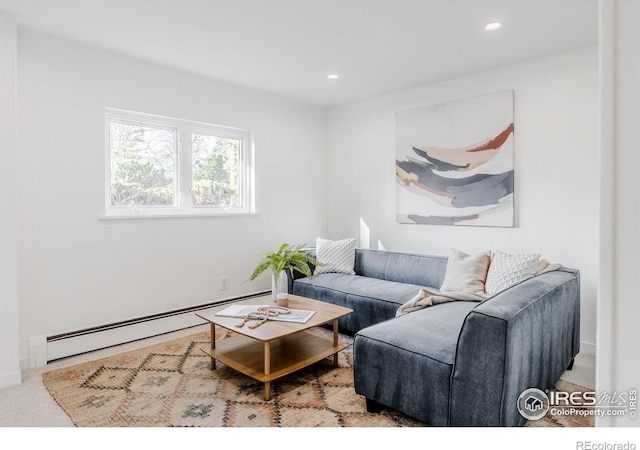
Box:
xmin=485 ymin=251 xmax=540 ymax=295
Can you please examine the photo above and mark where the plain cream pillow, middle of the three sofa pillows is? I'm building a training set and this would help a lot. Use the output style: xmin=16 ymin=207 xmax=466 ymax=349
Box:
xmin=440 ymin=248 xmax=491 ymax=292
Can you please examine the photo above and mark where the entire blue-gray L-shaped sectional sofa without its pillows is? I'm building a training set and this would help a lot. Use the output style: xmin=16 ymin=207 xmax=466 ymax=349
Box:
xmin=289 ymin=249 xmax=580 ymax=426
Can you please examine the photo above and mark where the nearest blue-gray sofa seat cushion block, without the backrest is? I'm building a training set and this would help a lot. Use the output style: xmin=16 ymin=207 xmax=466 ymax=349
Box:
xmin=353 ymin=302 xmax=475 ymax=426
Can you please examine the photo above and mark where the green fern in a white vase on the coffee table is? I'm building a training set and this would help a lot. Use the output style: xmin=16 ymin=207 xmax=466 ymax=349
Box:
xmin=249 ymin=244 xmax=322 ymax=301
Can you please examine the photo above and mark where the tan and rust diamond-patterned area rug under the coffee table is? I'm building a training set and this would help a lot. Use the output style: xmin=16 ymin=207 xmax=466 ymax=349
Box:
xmin=43 ymin=329 xmax=593 ymax=427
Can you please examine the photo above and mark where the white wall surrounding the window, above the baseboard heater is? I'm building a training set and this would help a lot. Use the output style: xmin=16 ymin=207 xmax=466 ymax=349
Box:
xmin=18 ymin=29 xmax=327 ymax=358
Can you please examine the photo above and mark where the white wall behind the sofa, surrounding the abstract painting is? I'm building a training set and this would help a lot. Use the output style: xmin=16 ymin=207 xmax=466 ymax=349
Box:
xmin=328 ymin=48 xmax=598 ymax=353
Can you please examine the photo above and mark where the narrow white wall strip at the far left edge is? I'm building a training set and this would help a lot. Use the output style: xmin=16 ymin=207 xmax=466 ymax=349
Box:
xmin=0 ymin=11 xmax=21 ymax=388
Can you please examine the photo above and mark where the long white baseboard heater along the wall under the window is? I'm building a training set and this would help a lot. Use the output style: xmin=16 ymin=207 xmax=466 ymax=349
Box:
xmin=46 ymin=291 xmax=270 ymax=362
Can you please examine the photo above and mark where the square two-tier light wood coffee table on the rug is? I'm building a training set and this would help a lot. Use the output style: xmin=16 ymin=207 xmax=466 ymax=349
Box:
xmin=196 ymin=294 xmax=353 ymax=400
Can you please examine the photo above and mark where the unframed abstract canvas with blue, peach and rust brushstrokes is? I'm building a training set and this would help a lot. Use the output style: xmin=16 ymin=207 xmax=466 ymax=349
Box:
xmin=396 ymin=91 xmax=514 ymax=227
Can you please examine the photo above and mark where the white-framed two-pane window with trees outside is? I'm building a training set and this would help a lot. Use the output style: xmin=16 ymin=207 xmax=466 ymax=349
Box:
xmin=105 ymin=109 xmax=254 ymax=217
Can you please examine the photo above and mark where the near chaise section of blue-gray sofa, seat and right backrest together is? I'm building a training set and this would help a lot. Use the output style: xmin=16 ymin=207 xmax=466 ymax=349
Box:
xmin=354 ymin=269 xmax=580 ymax=426
